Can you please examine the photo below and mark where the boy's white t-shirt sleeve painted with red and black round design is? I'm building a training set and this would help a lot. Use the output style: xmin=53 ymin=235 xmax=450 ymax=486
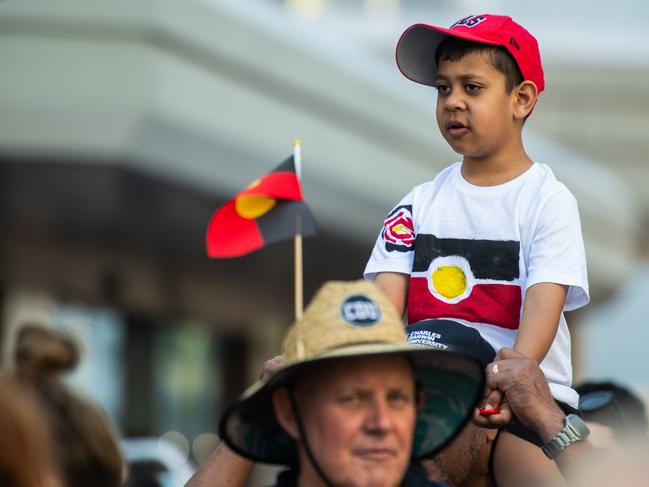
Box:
xmin=363 ymin=192 xmax=416 ymax=281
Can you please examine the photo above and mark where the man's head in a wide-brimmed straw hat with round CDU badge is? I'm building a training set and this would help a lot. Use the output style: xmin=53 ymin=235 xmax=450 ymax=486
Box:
xmin=220 ymin=281 xmax=483 ymax=487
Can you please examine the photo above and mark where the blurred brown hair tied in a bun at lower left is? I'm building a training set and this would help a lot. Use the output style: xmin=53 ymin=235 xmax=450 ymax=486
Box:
xmin=14 ymin=325 xmax=124 ymax=487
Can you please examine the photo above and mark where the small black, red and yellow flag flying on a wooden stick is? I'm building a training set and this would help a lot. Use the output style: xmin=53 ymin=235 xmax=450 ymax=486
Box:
xmin=206 ymin=156 xmax=316 ymax=258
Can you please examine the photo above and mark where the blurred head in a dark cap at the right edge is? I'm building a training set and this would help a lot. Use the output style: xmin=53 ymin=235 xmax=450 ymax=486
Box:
xmin=575 ymin=382 xmax=648 ymax=446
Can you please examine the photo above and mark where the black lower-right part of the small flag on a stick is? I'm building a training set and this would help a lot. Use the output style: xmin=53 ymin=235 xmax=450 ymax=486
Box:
xmin=256 ymin=201 xmax=318 ymax=243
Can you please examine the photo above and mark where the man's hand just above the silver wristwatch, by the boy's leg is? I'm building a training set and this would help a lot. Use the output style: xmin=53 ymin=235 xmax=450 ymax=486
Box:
xmin=473 ymin=348 xmax=565 ymax=442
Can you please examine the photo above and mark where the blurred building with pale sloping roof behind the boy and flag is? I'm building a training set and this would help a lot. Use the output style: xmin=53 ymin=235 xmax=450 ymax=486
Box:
xmin=0 ymin=0 xmax=649 ymax=476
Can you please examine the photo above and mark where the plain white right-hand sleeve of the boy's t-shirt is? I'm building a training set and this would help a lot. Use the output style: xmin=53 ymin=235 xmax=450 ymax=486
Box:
xmin=526 ymin=188 xmax=590 ymax=311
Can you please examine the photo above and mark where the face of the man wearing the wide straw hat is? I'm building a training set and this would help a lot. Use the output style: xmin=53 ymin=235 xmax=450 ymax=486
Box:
xmin=286 ymin=356 xmax=416 ymax=487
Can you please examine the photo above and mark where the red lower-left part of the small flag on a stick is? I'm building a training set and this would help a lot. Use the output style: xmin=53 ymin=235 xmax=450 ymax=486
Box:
xmin=206 ymin=199 xmax=264 ymax=258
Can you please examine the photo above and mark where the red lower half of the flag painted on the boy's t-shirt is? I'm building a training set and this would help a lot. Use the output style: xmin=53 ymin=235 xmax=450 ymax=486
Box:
xmin=408 ymin=277 xmax=522 ymax=330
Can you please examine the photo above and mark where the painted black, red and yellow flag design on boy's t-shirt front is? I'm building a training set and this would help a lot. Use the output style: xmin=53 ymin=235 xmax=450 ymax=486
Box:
xmin=408 ymin=234 xmax=522 ymax=330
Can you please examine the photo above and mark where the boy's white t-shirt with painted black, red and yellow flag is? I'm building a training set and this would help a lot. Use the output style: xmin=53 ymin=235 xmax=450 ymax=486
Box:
xmin=364 ymin=162 xmax=589 ymax=408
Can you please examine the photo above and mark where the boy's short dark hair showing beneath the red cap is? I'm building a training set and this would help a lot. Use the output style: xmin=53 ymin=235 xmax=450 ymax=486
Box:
xmin=435 ymin=37 xmax=524 ymax=93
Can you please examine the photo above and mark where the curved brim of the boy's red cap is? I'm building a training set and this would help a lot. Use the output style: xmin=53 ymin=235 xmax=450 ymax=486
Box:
xmin=396 ymin=24 xmax=500 ymax=86
